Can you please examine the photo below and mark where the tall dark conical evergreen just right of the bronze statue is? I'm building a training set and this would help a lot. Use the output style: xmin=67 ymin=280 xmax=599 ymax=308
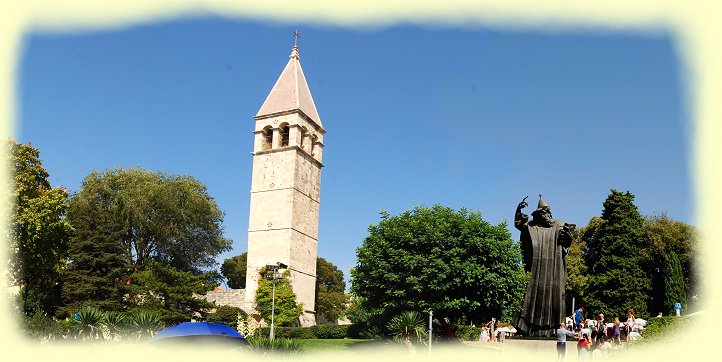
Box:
xmin=583 ymin=190 xmax=652 ymax=317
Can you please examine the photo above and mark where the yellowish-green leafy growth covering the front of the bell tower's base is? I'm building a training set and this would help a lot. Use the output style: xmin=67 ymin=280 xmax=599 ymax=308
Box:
xmin=256 ymin=267 xmax=303 ymax=327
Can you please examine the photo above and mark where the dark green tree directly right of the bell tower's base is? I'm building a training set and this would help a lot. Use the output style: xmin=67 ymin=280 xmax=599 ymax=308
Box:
xmin=316 ymin=257 xmax=348 ymax=322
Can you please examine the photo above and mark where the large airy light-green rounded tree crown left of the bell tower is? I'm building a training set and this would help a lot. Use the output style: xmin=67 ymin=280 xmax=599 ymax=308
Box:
xmin=68 ymin=168 xmax=231 ymax=273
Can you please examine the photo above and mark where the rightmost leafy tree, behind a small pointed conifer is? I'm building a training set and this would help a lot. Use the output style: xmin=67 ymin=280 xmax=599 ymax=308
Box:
xmin=644 ymin=213 xmax=700 ymax=312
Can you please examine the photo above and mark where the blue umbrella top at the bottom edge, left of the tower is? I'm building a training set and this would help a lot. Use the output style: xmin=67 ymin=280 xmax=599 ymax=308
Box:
xmin=151 ymin=322 xmax=248 ymax=345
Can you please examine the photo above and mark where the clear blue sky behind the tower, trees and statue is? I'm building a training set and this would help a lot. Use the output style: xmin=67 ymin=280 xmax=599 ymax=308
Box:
xmin=15 ymin=17 xmax=694 ymax=286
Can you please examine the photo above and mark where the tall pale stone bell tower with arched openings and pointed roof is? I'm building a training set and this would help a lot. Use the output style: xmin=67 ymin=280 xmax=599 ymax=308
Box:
xmin=246 ymin=42 xmax=326 ymax=326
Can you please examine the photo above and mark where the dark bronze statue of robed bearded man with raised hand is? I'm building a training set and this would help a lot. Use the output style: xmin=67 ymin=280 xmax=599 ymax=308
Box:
xmin=512 ymin=195 xmax=576 ymax=336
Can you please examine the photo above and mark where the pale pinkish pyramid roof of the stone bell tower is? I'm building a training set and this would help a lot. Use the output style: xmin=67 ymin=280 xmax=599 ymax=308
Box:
xmin=256 ymin=46 xmax=323 ymax=128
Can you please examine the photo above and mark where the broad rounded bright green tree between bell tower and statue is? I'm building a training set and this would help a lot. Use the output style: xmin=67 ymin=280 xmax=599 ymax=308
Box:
xmin=351 ymin=205 xmax=528 ymax=328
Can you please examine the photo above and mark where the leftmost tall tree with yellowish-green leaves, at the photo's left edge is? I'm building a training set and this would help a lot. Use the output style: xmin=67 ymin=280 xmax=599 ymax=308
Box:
xmin=6 ymin=140 xmax=72 ymax=315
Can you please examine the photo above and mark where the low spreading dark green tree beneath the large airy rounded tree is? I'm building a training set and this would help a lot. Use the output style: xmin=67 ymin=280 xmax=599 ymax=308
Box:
xmin=131 ymin=260 xmax=217 ymax=325
